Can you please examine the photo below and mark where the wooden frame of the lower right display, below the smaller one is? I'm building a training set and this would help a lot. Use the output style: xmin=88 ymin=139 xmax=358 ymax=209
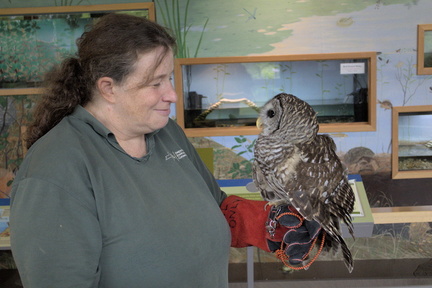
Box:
xmin=392 ymin=105 xmax=432 ymax=179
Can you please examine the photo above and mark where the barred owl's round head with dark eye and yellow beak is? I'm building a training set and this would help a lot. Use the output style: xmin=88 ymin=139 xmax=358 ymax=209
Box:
xmin=260 ymin=93 xmax=319 ymax=143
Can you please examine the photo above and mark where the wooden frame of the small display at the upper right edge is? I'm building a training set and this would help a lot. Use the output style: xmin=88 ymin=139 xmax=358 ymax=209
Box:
xmin=417 ymin=24 xmax=432 ymax=75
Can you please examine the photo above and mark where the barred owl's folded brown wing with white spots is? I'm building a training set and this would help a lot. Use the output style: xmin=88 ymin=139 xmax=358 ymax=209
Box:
xmin=286 ymin=135 xmax=354 ymax=232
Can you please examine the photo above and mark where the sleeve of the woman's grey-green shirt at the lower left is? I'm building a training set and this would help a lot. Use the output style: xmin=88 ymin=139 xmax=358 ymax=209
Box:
xmin=10 ymin=178 xmax=102 ymax=288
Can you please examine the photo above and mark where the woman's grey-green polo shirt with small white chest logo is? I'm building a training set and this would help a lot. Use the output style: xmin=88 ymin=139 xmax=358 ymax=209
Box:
xmin=10 ymin=107 xmax=230 ymax=288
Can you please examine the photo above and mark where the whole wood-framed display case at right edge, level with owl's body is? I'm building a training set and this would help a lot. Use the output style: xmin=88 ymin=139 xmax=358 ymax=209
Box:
xmin=392 ymin=106 xmax=432 ymax=179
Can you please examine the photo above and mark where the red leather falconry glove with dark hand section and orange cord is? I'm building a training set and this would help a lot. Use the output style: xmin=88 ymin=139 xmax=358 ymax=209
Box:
xmin=220 ymin=196 xmax=324 ymax=269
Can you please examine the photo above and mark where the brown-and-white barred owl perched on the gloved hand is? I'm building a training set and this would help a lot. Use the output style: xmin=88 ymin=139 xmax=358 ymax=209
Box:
xmin=253 ymin=93 xmax=355 ymax=272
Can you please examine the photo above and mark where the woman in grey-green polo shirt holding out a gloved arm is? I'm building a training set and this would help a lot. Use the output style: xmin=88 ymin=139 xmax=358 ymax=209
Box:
xmin=10 ymin=14 xmax=318 ymax=288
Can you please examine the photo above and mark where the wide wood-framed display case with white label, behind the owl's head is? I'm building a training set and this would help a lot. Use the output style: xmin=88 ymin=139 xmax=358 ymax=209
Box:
xmin=175 ymin=52 xmax=376 ymax=137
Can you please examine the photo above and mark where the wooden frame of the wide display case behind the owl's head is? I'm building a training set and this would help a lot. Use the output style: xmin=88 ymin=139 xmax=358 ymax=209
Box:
xmin=174 ymin=52 xmax=376 ymax=137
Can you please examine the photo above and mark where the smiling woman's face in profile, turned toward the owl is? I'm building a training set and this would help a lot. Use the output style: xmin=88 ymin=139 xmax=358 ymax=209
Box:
xmin=114 ymin=47 xmax=177 ymax=137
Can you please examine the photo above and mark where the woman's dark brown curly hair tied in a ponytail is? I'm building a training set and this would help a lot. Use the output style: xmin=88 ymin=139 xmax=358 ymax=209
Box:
xmin=26 ymin=14 xmax=176 ymax=148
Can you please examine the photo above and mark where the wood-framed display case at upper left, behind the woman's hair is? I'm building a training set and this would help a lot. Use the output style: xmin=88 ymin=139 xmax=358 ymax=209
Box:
xmin=0 ymin=3 xmax=154 ymax=88
